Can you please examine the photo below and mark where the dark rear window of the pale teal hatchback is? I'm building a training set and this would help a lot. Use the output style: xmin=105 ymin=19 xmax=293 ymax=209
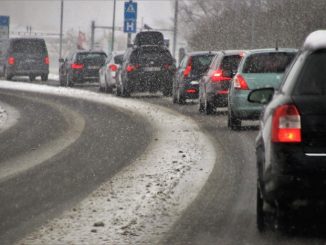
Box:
xmin=243 ymin=52 xmax=295 ymax=73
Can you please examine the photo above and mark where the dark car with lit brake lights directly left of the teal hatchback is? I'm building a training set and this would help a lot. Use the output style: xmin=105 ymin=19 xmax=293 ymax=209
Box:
xmin=199 ymin=50 xmax=244 ymax=114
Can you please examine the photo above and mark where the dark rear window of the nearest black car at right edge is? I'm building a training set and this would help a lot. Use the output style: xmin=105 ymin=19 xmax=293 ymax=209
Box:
xmin=295 ymin=50 xmax=326 ymax=95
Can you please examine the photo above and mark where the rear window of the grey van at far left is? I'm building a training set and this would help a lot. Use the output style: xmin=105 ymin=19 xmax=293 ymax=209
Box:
xmin=11 ymin=39 xmax=47 ymax=54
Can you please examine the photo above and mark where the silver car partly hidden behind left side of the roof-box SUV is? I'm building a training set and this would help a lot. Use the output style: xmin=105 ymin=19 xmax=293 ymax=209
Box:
xmin=99 ymin=52 xmax=124 ymax=93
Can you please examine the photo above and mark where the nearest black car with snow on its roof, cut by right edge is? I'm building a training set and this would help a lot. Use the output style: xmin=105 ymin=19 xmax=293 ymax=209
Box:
xmin=248 ymin=31 xmax=326 ymax=231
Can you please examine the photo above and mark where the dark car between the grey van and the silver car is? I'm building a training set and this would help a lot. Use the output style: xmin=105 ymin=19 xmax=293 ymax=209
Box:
xmin=59 ymin=51 xmax=107 ymax=87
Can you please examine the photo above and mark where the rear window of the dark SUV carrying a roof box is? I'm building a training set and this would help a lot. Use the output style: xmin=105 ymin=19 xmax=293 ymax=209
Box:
xmin=130 ymin=47 xmax=173 ymax=64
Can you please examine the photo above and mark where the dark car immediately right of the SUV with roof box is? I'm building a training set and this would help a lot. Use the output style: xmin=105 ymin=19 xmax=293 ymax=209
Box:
xmin=172 ymin=51 xmax=217 ymax=104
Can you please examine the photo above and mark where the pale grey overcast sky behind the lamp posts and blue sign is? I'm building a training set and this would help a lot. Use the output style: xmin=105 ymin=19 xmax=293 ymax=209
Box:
xmin=0 ymin=0 xmax=174 ymax=37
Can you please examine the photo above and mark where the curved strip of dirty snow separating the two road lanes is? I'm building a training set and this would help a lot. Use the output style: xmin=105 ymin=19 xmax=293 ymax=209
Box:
xmin=0 ymin=82 xmax=216 ymax=244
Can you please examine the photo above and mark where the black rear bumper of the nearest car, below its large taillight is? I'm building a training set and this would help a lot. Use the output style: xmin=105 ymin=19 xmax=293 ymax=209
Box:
xmin=264 ymin=144 xmax=326 ymax=202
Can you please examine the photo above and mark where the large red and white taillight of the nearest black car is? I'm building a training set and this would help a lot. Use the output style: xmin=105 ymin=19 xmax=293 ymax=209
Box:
xmin=272 ymin=105 xmax=301 ymax=143
